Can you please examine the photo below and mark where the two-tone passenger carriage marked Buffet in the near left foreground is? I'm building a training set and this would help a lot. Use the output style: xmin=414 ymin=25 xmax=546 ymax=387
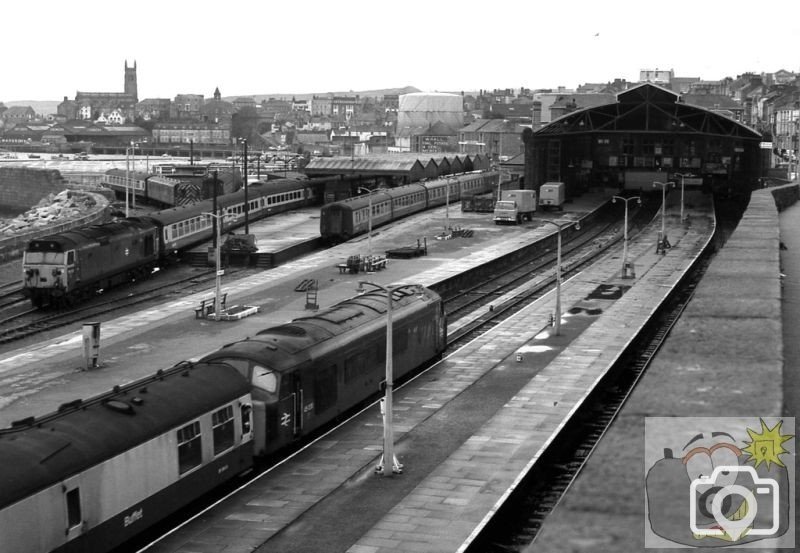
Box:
xmin=0 ymin=364 xmax=252 ymax=553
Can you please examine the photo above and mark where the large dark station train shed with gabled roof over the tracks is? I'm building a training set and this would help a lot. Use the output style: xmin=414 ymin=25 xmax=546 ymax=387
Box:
xmin=523 ymin=83 xmax=768 ymax=196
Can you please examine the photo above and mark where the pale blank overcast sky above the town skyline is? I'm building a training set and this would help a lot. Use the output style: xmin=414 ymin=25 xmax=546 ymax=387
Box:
xmin=0 ymin=0 xmax=800 ymax=101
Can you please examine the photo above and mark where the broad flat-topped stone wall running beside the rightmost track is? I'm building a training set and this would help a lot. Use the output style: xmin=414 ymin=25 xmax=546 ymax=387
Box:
xmin=526 ymin=184 xmax=798 ymax=553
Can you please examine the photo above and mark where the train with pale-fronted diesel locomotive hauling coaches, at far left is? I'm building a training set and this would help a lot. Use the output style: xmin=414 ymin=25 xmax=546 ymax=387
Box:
xmin=22 ymin=179 xmax=320 ymax=307
